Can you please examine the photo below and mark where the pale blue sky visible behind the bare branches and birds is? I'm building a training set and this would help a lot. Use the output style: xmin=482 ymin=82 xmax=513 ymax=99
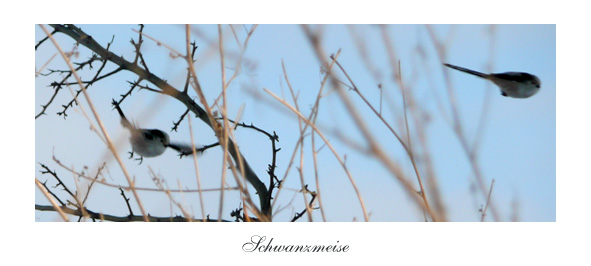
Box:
xmin=35 ymin=25 xmax=556 ymax=221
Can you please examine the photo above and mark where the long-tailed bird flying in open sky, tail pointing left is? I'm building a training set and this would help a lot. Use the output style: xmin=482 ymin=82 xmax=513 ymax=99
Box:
xmin=443 ymin=63 xmax=541 ymax=98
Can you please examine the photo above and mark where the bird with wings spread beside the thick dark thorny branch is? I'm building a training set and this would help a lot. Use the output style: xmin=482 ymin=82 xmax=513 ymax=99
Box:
xmin=112 ymin=99 xmax=199 ymax=159
